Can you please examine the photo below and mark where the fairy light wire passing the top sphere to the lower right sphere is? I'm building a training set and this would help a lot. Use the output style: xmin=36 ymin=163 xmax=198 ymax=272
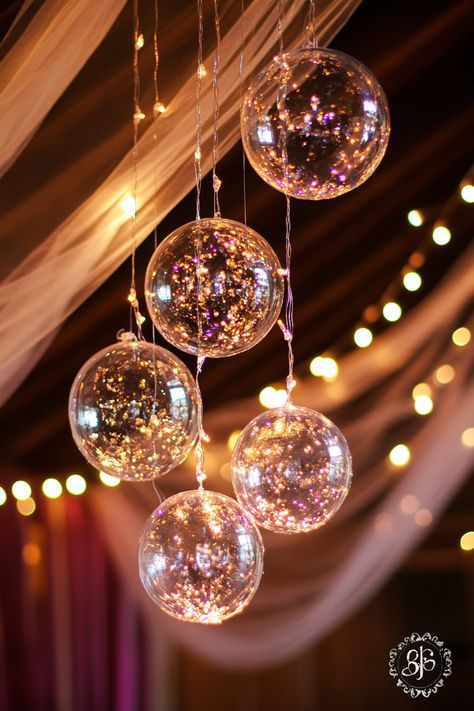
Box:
xmin=277 ymin=0 xmax=296 ymax=405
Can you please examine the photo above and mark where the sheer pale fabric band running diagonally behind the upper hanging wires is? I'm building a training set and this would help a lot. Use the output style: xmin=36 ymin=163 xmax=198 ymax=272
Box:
xmin=0 ymin=0 xmax=360 ymax=404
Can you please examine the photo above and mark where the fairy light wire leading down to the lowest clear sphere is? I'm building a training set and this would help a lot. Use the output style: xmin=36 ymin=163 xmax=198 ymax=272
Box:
xmin=194 ymin=0 xmax=208 ymax=491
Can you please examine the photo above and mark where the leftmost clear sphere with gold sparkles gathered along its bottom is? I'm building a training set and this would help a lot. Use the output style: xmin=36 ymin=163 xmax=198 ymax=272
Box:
xmin=69 ymin=340 xmax=197 ymax=481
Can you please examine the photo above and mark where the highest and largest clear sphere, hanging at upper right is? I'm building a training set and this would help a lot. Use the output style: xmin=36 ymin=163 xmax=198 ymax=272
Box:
xmin=241 ymin=48 xmax=390 ymax=200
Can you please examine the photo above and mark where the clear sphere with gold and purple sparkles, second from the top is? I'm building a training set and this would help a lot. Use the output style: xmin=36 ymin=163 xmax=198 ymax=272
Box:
xmin=145 ymin=218 xmax=284 ymax=358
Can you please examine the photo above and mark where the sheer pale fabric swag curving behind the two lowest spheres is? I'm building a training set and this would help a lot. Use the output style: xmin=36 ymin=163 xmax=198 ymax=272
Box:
xmin=90 ymin=250 xmax=474 ymax=669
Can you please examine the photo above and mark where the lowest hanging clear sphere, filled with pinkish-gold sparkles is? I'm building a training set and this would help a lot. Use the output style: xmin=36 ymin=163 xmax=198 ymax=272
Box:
xmin=138 ymin=490 xmax=263 ymax=624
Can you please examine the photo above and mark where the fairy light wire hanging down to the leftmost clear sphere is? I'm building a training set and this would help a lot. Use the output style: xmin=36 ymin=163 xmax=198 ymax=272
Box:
xmin=128 ymin=0 xmax=145 ymax=341
